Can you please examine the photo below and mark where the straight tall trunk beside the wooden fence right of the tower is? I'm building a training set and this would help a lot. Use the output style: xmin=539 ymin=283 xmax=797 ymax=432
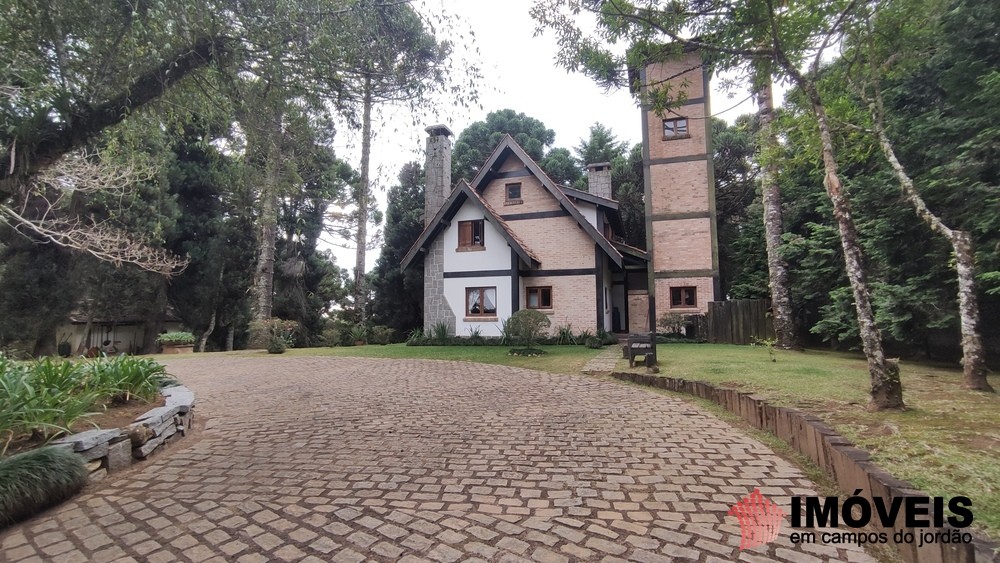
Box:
xmin=756 ymin=79 xmax=797 ymax=350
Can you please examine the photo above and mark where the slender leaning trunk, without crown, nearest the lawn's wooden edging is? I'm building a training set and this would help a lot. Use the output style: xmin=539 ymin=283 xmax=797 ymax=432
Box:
xmin=781 ymin=67 xmax=905 ymax=410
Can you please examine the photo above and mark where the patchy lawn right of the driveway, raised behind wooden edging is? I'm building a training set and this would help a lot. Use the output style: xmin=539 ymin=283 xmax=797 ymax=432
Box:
xmin=618 ymin=344 xmax=1000 ymax=539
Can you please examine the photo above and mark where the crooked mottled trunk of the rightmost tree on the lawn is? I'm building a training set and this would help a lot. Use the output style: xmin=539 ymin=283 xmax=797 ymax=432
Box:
xmin=869 ymin=101 xmax=993 ymax=393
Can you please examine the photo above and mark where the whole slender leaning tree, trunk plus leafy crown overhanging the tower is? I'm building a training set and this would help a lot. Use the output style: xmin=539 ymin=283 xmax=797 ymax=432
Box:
xmin=532 ymin=0 xmax=904 ymax=409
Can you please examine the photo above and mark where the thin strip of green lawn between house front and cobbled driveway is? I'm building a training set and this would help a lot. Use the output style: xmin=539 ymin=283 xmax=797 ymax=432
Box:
xmin=239 ymin=344 xmax=600 ymax=373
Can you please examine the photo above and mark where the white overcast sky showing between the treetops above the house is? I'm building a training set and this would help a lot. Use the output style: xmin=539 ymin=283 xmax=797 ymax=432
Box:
xmin=326 ymin=0 xmax=755 ymax=270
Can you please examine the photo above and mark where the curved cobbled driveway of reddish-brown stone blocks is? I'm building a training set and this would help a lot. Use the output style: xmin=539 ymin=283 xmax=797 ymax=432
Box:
xmin=0 ymin=355 xmax=871 ymax=563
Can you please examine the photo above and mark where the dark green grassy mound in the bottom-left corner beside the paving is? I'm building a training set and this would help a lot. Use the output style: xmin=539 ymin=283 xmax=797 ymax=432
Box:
xmin=0 ymin=447 xmax=87 ymax=528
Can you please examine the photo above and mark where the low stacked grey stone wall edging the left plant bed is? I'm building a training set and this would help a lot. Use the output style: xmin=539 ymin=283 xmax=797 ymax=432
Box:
xmin=53 ymin=385 xmax=195 ymax=481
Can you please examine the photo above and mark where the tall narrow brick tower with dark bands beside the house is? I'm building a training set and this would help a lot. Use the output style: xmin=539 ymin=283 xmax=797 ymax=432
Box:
xmin=640 ymin=51 xmax=719 ymax=324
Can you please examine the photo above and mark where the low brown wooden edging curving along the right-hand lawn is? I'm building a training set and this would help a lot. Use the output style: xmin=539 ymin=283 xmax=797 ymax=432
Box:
xmin=611 ymin=372 xmax=1000 ymax=563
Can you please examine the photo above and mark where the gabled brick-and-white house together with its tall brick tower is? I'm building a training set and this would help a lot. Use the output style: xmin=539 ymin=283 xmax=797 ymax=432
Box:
xmin=403 ymin=50 xmax=720 ymax=336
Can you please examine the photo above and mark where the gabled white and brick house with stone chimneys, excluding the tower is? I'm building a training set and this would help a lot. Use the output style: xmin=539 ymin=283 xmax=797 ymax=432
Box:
xmin=402 ymin=126 xmax=647 ymax=336
